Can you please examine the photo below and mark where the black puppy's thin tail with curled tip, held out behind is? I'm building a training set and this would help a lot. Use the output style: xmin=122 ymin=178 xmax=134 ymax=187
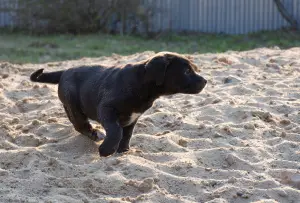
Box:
xmin=30 ymin=69 xmax=64 ymax=84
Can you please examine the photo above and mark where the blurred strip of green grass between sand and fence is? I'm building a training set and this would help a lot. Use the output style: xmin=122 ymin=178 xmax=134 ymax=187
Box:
xmin=0 ymin=31 xmax=300 ymax=63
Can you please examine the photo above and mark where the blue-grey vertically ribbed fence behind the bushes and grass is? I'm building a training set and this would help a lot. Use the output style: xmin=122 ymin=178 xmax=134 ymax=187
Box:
xmin=0 ymin=0 xmax=300 ymax=34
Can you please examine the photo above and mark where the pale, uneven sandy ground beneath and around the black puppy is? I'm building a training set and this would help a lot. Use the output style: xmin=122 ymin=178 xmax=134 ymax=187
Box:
xmin=0 ymin=48 xmax=300 ymax=203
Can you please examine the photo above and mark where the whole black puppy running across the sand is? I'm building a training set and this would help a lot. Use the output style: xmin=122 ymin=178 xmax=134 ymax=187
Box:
xmin=30 ymin=52 xmax=206 ymax=156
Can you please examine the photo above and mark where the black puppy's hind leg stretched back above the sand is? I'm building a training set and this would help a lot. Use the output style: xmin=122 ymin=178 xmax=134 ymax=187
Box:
xmin=64 ymin=105 xmax=104 ymax=141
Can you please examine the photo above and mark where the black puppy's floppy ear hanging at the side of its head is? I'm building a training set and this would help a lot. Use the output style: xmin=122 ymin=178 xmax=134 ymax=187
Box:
xmin=144 ymin=55 xmax=172 ymax=86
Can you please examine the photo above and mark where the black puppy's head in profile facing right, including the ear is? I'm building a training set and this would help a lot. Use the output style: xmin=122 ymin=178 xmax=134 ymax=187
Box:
xmin=144 ymin=52 xmax=207 ymax=94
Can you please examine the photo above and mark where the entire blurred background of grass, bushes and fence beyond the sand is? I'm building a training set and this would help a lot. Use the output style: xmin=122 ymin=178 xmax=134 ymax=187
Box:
xmin=0 ymin=0 xmax=300 ymax=63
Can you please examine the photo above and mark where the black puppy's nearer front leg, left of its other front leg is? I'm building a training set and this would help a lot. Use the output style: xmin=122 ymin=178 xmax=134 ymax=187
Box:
xmin=98 ymin=107 xmax=123 ymax=156
